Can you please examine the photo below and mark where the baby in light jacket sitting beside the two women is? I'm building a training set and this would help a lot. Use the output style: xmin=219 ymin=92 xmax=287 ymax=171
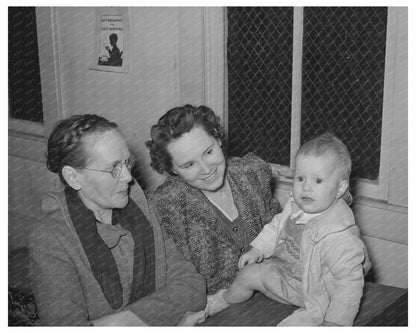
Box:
xmin=205 ymin=134 xmax=371 ymax=326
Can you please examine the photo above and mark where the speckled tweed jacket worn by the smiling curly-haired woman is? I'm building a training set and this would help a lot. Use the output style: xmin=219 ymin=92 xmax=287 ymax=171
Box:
xmin=153 ymin=153 xmax=281 ymax=294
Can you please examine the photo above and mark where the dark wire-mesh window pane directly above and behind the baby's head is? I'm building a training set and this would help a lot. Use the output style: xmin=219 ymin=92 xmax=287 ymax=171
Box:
xmin=301 ymin=7 xmax=387 ymax=179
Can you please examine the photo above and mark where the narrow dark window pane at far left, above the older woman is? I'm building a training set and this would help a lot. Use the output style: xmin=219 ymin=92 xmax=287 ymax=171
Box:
xmin=9 ymin=7 xmax=43 ymax=122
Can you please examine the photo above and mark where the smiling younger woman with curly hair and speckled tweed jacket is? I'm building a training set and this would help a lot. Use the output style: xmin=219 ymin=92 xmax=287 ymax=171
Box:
xmin=146 ymin=105 xmax=280 ymax=295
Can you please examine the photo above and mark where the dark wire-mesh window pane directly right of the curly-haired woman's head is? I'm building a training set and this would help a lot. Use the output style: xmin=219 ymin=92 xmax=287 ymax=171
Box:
xmin=227 ymin=7 xmax=293 ymax=165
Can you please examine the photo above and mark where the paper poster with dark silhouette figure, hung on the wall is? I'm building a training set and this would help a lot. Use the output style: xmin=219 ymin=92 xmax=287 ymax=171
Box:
xmin=90 ymin=7 xmax=130 ymax=73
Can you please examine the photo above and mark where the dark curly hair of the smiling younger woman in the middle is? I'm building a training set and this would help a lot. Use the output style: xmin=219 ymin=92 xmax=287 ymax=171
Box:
xmin=145 ymin=104 xmax=224 ymax=175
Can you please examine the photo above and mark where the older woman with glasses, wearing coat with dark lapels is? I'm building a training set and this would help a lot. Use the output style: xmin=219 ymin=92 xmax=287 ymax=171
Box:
xmin=29 ymin=115 xmax=205 ymax=326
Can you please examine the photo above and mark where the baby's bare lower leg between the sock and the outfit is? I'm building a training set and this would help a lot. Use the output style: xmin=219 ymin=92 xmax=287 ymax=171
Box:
xmin=223 ymin=264 xmax=264 ymax=304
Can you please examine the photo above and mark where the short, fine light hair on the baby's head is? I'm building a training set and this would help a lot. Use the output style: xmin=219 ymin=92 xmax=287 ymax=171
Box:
xmin=296 ymin=133 xmax=353 ymax=205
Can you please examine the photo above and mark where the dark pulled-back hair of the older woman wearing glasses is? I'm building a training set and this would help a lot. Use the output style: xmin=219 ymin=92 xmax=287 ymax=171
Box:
xmin=46 ymin=114 xmax=118 ymax=185
